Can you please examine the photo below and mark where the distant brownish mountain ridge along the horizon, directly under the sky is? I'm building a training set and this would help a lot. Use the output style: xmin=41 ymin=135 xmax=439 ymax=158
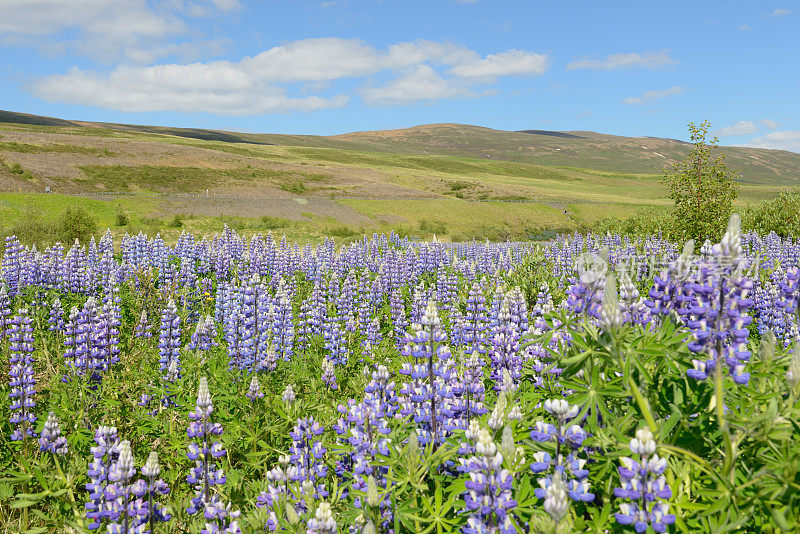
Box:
xmin=0 ymin=111 xmax=800 ymax=186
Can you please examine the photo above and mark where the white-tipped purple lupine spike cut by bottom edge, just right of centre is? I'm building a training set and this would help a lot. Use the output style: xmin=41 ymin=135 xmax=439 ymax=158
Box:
xmin=461 ymin=428 xmax=517 ymax=534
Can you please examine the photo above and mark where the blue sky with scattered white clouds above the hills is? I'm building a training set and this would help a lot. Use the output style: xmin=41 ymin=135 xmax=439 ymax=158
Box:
xmin=0 ymin=0 xmax=800 ymax=152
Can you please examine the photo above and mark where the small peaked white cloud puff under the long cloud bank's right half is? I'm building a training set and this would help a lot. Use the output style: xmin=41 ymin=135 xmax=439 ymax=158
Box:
xmin=361 ymin=65 xmax=472 ymax=106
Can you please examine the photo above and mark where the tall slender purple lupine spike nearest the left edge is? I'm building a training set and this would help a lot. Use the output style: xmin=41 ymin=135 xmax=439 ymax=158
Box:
xmin=8 ymin=308 xmax=36 ymax=441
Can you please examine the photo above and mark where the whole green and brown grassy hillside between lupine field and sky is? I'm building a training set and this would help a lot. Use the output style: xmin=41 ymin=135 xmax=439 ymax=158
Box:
xmin=0 ymin=112 xmax=800 ymax=245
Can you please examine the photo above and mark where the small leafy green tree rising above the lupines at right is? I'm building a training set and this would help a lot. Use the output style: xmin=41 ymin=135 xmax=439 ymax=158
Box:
xmin=664 ymin=121 xmax=738 ymax=247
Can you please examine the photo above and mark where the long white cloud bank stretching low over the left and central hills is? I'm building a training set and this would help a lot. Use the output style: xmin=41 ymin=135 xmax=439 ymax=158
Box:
xmin=33 ymin=38 xmax=547 ymax=115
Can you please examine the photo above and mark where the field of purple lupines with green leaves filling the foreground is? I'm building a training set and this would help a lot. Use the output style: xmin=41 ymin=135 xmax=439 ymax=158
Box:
xmin=0 ymin=217 xmax=800 ymax=534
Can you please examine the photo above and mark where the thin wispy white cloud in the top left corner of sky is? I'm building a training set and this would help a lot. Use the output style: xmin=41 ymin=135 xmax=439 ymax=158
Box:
xmin=0 ymin=0 xmax=234 ymax=62
